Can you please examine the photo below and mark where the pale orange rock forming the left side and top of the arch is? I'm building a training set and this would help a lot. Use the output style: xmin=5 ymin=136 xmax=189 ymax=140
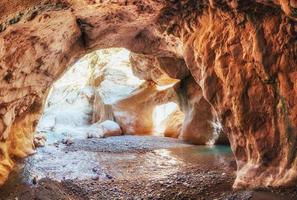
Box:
xmin=0 ymin=1 xmax=180 ymax=183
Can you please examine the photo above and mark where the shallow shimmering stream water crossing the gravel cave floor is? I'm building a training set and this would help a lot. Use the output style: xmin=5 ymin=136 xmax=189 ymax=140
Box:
xmin=0 ymin=145 xmax=232 ymax=196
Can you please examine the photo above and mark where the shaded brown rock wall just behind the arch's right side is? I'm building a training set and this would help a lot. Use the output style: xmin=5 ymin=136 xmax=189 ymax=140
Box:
xmin=130 ymin=53 xmax=216 ymax=145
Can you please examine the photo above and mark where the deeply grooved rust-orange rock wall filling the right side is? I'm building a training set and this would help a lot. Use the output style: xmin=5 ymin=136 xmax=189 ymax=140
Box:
xmin=160 ymin=1 xmax=297 ymax=188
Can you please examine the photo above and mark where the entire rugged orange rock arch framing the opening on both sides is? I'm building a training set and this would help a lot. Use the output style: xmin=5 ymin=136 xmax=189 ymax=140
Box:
xmin=0 ymin=0 xmax=297 ymax=188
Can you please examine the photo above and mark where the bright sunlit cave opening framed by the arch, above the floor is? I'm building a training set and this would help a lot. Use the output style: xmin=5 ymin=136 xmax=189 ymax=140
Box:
xmin=35 ymin=48 xmax=182 ymax=146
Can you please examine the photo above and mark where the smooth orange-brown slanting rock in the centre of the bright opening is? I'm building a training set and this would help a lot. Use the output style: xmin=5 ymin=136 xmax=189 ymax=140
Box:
xmin=112 ymin=82 xmax=177 ymax=135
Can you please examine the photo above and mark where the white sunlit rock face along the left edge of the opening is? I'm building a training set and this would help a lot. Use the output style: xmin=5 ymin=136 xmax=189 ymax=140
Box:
xmin=37 ymin=52 xmax=99 ymax=136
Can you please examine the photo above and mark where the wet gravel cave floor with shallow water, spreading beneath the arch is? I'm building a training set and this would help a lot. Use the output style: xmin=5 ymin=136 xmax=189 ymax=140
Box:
xmin=0 ymin=136 xmax=297 ymax=200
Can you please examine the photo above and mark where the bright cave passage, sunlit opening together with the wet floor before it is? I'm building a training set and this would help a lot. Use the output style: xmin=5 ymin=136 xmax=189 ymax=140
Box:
xmin=0 ymin=49 xmax=235 ymax=199
